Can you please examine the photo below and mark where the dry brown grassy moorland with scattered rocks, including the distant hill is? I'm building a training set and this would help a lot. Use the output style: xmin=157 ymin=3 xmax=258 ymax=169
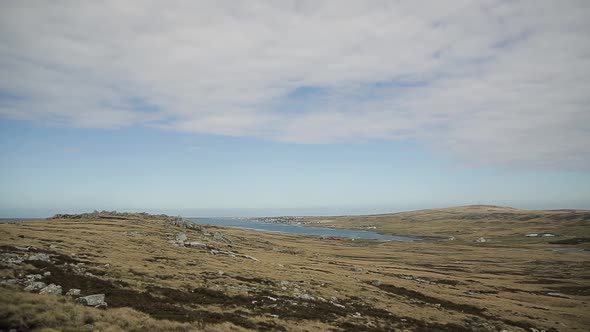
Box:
xmin=0 ymin=206 xmax=590 ymax=332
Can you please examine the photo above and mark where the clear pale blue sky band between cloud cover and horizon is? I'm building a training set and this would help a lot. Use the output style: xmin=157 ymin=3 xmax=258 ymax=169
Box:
xmin=0 ymin=121 xmax=590 ymax=217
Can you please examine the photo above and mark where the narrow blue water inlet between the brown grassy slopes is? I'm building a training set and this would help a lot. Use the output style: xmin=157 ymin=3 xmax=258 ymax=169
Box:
xmin=187 ymin=218 xmax=418 ymax=242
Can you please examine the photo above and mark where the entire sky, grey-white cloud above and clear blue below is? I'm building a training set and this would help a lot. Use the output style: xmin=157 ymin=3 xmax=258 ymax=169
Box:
xmin=0 ymin=0 xmax=590 ymax=217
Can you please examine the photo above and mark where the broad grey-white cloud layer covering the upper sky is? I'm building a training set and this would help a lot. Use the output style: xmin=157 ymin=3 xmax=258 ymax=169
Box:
xmin=0 ymin=0 xmax=590 ymax=168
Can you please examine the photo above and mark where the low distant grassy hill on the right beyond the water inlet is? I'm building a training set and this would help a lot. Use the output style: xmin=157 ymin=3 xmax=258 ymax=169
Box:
xmin=305 ymin=205 xmax=590 ymax=243
